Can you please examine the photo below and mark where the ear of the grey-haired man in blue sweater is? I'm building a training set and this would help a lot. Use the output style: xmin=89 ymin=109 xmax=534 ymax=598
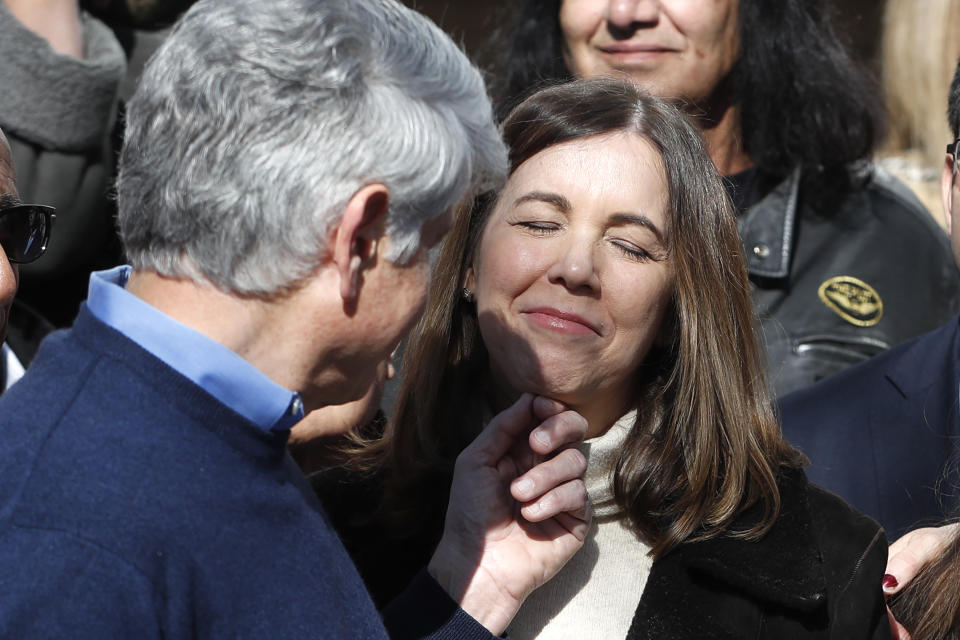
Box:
xmin=333 ymin=184 xmax=390 ymax=306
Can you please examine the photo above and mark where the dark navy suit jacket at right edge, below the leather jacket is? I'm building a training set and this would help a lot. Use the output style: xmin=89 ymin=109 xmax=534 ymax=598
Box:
xmin=780 ymin=317 xmax=960 ymax=539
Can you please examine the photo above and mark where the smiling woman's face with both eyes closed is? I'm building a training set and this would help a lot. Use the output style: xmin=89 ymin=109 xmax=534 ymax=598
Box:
xmin=466 ymin=133 xmax=673 ymax=417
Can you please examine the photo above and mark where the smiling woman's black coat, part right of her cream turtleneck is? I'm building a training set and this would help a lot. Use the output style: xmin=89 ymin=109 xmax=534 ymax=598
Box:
xmin=627 ymin=473 xmax=890 ymax=640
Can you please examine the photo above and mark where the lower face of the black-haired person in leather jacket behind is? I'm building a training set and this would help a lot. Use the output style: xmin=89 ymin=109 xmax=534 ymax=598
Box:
xmin=560 ymin=0 xmax=739 ymax=103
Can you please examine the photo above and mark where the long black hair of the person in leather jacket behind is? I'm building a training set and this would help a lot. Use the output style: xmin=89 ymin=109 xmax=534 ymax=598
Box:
xmin=493 ymin=0 xmax=883 ymax=212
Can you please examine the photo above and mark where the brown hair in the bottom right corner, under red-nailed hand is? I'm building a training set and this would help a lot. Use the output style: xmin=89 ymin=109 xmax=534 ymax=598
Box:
xmin=888 ymin=529 xmax=960 ymax=640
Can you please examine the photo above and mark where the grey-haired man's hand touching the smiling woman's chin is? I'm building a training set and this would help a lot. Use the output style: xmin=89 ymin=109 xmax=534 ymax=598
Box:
xmin=428 ymin=394 xmax=590 ymax=635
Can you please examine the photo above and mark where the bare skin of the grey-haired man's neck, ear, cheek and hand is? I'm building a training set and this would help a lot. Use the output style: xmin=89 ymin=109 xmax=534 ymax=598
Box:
xmin=126 ymin=183 xmax=590 ymax=635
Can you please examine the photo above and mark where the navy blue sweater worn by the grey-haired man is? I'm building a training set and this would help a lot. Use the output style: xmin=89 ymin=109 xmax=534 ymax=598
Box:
xmin=0 ymin=308 xmax=490 ymax=638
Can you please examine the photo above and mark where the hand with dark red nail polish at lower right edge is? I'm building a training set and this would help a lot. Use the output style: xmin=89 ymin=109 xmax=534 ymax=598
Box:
xmin=883 ymin=522 xmax=960 ymax=640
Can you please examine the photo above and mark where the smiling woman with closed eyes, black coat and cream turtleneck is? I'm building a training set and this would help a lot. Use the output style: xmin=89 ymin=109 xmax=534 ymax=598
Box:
xmin=314 ymin=79 xmax=889 ymax=640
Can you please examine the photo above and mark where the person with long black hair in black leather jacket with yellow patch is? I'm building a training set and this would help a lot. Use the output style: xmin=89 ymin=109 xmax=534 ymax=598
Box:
xmin=495 ymin=0 xmax=960 ymax=395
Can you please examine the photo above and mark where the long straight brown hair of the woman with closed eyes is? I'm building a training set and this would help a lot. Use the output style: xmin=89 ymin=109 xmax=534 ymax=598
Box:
xmin=379 ymin=79 xmax=801 ymax=556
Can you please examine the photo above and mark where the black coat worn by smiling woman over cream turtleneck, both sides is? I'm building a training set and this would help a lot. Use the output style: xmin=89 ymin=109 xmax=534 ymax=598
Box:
xmin=311 ymin=470 xmax=890 ymax=640
